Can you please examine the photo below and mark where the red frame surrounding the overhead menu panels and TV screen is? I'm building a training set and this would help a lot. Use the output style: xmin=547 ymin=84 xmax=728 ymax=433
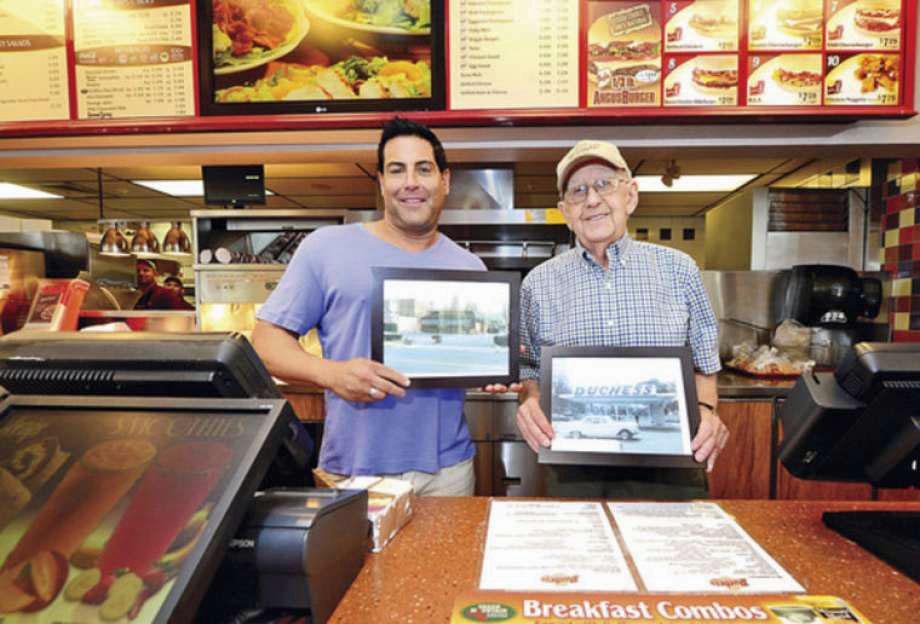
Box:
xmin=0 ymin=0 xmax=918 ymax=138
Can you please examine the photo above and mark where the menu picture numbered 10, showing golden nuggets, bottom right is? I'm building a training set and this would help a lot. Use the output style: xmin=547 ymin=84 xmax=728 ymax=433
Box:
xmin=824 ymin=53 xmax=901 ymax=106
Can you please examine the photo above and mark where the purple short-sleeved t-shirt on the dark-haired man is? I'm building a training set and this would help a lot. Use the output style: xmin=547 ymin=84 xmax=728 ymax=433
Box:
xmin=258 ymin=224 xmax=485 ymax=475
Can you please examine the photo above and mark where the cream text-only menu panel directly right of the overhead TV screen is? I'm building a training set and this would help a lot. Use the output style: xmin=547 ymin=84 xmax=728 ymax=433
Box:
xmin=450 ymin=0 xmax=578 ymax=110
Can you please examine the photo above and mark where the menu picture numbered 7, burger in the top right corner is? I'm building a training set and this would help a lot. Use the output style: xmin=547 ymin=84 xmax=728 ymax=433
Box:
xmin=827 ymin=0 xmax=901 ymax=50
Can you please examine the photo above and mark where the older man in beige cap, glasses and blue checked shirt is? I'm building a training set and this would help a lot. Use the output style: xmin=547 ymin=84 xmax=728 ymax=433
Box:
xmin=517 ymin=141 xmax=728 ymax=499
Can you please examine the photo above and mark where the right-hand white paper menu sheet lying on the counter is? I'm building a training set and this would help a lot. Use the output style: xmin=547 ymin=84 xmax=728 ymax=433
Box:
xmin=607 ymin=503 xmax=805 ymax=593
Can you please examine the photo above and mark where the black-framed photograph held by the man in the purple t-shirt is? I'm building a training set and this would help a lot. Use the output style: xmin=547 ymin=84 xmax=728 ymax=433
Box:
xmin=371 ymin=267 xmax=521 ymax=388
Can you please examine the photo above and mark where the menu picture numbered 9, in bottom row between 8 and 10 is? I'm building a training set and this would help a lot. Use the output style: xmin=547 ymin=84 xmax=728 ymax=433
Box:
xmin=747 ymin=54 xmax=823 ymax=106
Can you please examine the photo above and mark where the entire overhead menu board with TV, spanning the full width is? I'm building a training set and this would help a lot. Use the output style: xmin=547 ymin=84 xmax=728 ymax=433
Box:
xmin=0 ymin=0 xmax=918 ymax=134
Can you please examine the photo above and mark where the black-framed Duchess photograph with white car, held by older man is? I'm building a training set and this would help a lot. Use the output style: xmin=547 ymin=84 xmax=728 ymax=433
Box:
xmin=539 ymin=347 xmax=700 ymax=468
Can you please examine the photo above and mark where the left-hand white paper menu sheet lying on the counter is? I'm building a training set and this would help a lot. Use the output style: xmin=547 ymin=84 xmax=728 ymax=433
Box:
xmin=479 ymin=500 xmax=636 ymax=592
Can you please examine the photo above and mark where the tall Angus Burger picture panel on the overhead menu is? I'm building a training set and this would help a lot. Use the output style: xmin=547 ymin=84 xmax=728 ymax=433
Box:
xmin=586 ymin=1 xmax=661 ymax=107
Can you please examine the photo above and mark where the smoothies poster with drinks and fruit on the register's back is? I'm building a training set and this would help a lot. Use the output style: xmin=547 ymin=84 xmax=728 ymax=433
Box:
xmin=0 ymin=411 xmax=255 ymax=623
